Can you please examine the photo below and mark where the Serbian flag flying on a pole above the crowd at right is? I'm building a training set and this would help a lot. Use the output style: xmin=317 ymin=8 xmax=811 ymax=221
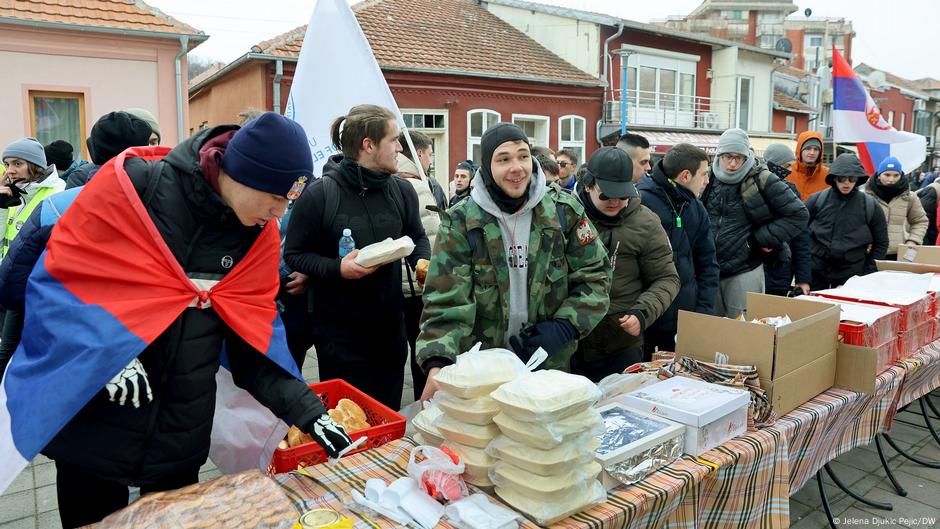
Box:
xmin=832 ymin=46 xmax=927 ymax=174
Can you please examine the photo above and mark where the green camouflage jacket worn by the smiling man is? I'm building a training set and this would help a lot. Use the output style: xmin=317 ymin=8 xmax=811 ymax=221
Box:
xmin=416 ymin=186 xmax=611 ymax=370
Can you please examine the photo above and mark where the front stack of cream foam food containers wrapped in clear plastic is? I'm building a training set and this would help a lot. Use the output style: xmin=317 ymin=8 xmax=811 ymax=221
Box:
xmin=486 ymin=370 xmax=606 ymax=525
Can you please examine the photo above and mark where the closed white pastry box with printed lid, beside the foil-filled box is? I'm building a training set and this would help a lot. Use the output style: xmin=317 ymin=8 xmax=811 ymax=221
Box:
xmin=618 ymin=376 xmax=751 ymax=456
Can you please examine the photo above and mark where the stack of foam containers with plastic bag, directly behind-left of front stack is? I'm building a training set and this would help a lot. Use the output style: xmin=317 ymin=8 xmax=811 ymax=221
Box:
xmin=434 ymin=355 xmax=521 ymax=488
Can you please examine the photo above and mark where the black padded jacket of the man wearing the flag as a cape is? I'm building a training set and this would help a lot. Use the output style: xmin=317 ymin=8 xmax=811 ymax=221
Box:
xmin=43 ymin=126 xmax=325 ymax=485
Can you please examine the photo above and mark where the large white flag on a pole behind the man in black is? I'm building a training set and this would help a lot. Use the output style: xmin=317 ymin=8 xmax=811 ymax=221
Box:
xmin=284 ymin=0 xmax=404 ymax=176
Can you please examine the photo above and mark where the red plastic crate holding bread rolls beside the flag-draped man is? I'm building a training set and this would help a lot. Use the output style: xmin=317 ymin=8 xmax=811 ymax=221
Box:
xmin=268 ymin=379 xmax=405 ymax=474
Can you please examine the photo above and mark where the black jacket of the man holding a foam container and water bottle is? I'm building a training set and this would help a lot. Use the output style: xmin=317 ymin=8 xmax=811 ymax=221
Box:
xmin=284 ymin=155 xmax=431 ymax=337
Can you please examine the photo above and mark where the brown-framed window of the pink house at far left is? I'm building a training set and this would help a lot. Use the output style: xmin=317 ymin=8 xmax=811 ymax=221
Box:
xmin=29 ymin=90 xmax=87 ymax=162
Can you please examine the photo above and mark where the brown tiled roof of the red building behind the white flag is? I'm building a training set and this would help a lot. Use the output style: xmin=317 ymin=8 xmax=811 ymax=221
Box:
xmin=252 ymin=0 xmax=600 ymax=85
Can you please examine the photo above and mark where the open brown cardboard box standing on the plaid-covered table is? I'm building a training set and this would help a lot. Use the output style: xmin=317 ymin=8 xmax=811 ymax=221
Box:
xmin=676 ymin=293 xmax=840 ymax=380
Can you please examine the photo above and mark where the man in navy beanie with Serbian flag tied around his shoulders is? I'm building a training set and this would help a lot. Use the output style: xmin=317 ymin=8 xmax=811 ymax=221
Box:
xmin=0 ymin=113 xmax=350 ymax=527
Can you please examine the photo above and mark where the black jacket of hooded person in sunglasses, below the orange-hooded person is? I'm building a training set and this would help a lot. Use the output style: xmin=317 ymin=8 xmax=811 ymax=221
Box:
xmin=806 ymin=187 xmax=888 ymax=275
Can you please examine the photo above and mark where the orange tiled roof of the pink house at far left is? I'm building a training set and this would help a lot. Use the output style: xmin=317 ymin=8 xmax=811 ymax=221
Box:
xmin=0 ymin=0 xmax=205 ymax=36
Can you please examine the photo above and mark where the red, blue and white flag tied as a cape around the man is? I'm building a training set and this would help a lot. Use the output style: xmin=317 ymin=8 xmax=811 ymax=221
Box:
xmin=0 ymin=147 xmax=300 ymax=492
